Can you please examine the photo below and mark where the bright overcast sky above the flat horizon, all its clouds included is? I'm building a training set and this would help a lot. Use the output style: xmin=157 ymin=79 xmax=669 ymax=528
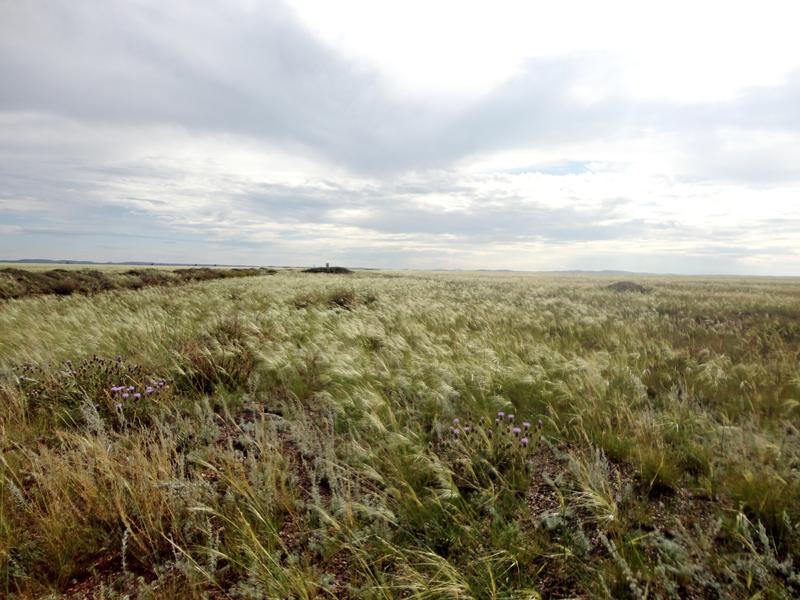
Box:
xmin=0 ymin=0 xmax=800 ymax=275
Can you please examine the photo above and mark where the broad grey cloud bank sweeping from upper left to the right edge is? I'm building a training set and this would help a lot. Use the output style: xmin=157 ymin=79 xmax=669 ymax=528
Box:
xmin=0 ymin=0 xmax=800 ymax=179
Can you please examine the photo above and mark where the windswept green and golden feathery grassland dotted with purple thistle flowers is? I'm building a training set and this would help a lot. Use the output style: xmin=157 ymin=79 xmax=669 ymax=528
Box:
xmin=0 ymin=271 xmax=800 ymax=599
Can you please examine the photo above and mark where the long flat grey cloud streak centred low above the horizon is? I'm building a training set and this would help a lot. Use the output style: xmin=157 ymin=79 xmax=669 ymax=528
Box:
xmin=233 ymin=180 xmax=673 ymax=244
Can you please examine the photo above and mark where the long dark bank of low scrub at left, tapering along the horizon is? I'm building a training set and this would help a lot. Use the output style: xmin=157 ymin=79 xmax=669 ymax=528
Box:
xmin=0 ymin=267 xmax=277 ymax=299
